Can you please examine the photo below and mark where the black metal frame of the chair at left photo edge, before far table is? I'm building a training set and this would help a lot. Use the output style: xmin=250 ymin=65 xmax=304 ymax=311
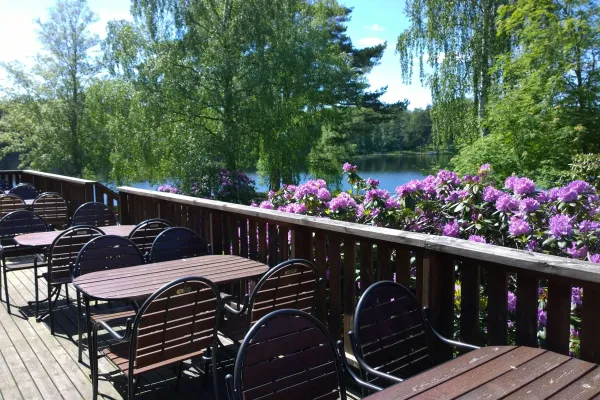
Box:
xmin=0 ymin=210 xmax=48 ymax=314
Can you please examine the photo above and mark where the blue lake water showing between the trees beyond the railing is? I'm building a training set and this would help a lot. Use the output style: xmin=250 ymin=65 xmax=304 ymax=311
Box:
xmin=131 ymin=154 xmax=452 ymax=193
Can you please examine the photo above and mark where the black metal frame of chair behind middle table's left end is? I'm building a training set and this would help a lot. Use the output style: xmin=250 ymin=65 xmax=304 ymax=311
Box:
xmin=73 ymin=235 xmax=144 ymax=362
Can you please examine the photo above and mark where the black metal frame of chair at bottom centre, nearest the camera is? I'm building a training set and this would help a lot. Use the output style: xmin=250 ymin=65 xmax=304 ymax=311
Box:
xmin=225 ymin=309 xmax=380 ymax=400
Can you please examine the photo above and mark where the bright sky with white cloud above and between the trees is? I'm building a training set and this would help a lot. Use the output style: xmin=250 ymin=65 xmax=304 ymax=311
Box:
xmin=0 ymin=0 xmax=431 ymax=109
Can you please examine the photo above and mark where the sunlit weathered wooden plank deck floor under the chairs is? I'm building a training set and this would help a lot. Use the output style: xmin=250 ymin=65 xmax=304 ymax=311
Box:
xmin=0 ymin=258 xmax=234 ymax=400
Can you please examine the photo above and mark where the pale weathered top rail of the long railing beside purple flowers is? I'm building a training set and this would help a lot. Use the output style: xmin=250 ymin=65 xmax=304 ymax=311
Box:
xmin=118 ymin=186 xmax=600 ymax=283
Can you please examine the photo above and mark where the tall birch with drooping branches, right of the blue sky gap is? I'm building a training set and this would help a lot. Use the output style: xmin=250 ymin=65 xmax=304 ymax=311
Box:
xmin=396 ymin=0 xmax=509 ymax=144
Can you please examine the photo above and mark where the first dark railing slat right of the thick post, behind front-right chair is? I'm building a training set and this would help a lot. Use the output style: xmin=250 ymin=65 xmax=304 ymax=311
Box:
xmin=460 ymin=260 xmax=481 ymax=345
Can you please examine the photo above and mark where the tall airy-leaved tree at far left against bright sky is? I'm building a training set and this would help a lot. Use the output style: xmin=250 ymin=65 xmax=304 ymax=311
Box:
xmin=2 ymin=0 xmax=99 ymax=176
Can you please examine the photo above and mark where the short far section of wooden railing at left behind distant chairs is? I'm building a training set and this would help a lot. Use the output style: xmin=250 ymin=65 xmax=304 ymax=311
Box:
xmin=0 ymin=170 xmax=119 ymax=215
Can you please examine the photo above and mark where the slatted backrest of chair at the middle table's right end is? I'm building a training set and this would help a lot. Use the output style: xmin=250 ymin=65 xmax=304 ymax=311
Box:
xmin=248 ymin=259 xmax=320 ymax=326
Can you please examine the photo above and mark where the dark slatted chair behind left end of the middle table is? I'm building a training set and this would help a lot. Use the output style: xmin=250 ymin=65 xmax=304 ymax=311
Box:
xmin=73 ymin=235 xmax=144 ymax=362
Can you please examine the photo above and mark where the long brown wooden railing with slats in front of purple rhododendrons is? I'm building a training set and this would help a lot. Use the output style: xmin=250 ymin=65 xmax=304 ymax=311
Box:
xmin=118 ymin=187 xmax=600 ymax=363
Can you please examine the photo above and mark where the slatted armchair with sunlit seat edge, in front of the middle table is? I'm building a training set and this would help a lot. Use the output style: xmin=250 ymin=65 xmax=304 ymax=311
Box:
xmin=92 ymin=277 xmax=221 ymax=399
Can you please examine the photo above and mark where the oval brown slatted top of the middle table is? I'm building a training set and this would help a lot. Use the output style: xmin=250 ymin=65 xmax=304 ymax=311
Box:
xmin=73 ymin=256 xmax=269 ymax=301
